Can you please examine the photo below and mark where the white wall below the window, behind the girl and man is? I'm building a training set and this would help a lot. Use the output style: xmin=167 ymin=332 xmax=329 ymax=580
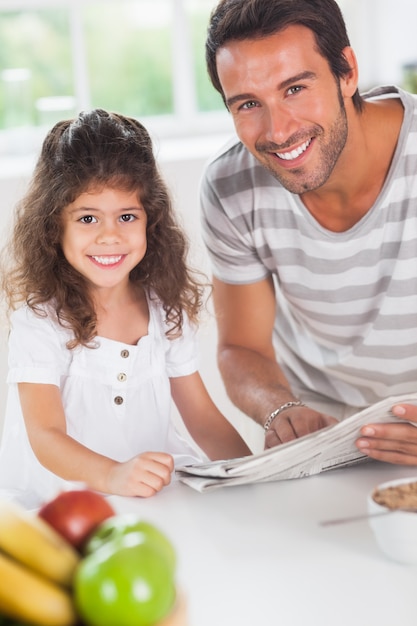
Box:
xmin=0 ymin=136 xmax=263 ymax=450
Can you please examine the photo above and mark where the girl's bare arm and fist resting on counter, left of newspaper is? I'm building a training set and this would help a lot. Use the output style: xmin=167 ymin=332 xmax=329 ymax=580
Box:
xmin=18 ymin=383 xmax=174 ymax=497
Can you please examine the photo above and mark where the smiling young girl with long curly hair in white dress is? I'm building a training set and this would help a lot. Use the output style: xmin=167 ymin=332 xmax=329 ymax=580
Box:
xmin=0 ymin=109 xmax=250 ymax=507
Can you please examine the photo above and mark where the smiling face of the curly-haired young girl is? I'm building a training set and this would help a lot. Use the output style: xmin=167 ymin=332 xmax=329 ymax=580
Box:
xmin=61 ymin=187 xmax=147 ymax=290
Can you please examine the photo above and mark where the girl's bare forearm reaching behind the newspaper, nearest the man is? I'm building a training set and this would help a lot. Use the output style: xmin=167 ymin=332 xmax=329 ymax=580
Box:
xmin=170 ymin=372 xmax=252 ymax=460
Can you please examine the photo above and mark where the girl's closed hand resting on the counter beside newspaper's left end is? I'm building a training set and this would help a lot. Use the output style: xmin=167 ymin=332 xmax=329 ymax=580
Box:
xmin=108 ymin=452 xmax=174 ymax=498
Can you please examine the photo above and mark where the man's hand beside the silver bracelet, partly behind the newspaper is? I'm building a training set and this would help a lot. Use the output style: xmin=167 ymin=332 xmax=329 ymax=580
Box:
xmin=265 ymin=406 xmax=336 ymax=448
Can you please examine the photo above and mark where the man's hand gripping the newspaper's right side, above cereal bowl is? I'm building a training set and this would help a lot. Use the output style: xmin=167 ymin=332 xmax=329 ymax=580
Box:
xmin=356 ymin=404 xmax=417 ymax=465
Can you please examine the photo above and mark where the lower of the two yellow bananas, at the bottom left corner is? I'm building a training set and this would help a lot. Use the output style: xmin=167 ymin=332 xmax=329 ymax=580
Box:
xmin=0 ymin=553 xmax=77 ymax=626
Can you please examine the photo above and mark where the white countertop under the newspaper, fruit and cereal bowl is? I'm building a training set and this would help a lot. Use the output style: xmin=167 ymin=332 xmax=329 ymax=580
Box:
xmin=111 ymin=462 xmax=417 ymax=626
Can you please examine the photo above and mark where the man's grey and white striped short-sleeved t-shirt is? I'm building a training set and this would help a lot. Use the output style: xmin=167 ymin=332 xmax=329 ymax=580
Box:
xmin=201 ymin=87 xmax=417 ymax=407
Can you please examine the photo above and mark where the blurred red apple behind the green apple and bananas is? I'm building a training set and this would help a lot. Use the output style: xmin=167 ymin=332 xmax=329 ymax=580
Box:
xmin=38 ymin=489 xmax=116 ymax=551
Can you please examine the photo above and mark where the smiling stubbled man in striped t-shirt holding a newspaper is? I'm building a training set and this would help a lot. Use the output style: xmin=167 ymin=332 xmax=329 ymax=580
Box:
xmin=201 ymin=0 xmax=417 ymax=465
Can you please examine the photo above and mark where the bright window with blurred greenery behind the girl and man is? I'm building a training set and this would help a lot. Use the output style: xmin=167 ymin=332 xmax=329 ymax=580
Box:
xmin=0 ymin=0 xmax=228 ymax=153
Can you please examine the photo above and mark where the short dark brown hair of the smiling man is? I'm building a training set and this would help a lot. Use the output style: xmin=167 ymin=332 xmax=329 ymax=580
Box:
xmin=206 ymin=0 xmax=363 ymax=111
